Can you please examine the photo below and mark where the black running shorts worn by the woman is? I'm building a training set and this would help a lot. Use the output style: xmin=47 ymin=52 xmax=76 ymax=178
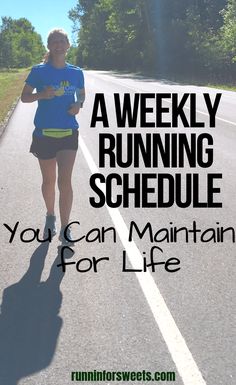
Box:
xmin=30 ymin=130 xmax=79 ymax=159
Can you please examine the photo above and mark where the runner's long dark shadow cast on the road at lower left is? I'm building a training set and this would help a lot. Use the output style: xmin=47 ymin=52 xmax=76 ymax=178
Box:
xmin=0 ymin=243 xmax=63 ymax=385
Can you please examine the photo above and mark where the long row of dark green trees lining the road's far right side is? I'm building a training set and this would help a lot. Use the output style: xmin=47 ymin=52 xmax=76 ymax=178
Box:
xmin=69 ymin=0 xmax=236 ymax=81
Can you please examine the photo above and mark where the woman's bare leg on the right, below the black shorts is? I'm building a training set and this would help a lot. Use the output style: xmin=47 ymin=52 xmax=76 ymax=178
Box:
xmin=56 ymin=150 xmax=77 ymax=227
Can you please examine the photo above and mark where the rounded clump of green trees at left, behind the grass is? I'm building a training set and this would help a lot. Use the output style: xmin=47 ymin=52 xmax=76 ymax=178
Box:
xmin=0 ymin=16 xmax=45 ymax=68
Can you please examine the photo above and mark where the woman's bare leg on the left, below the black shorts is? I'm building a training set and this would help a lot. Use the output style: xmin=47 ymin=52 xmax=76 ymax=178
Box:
xmin=39 ymin=158 xmax=56 ymax=215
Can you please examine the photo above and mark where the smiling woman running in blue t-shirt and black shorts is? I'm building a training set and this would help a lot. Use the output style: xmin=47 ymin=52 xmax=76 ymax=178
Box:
xmin=21 ymin=29 xmax=85 ymax=244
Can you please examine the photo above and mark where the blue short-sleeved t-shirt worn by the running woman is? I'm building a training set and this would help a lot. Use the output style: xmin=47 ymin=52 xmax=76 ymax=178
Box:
xmin=26 ymin=62 xmax=84 ymax=136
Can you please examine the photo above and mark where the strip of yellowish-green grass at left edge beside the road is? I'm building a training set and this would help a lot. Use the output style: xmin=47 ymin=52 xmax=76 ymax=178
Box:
xmin=0 ymin=68 xmax=29 ymax=127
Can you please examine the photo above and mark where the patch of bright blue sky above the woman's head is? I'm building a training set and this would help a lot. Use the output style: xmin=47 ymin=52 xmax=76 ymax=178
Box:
xmin=0 ymin=0 xmax=77 ymax=46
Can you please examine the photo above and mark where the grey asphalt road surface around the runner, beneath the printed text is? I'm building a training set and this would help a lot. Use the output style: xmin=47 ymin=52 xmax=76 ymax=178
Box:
xmin=0 ymin=71 xmax=236 ymax=385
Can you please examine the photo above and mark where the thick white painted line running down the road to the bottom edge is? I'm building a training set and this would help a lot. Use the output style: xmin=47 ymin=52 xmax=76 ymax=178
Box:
xmin=79 ymin=136 xmax=206 ymax=385
